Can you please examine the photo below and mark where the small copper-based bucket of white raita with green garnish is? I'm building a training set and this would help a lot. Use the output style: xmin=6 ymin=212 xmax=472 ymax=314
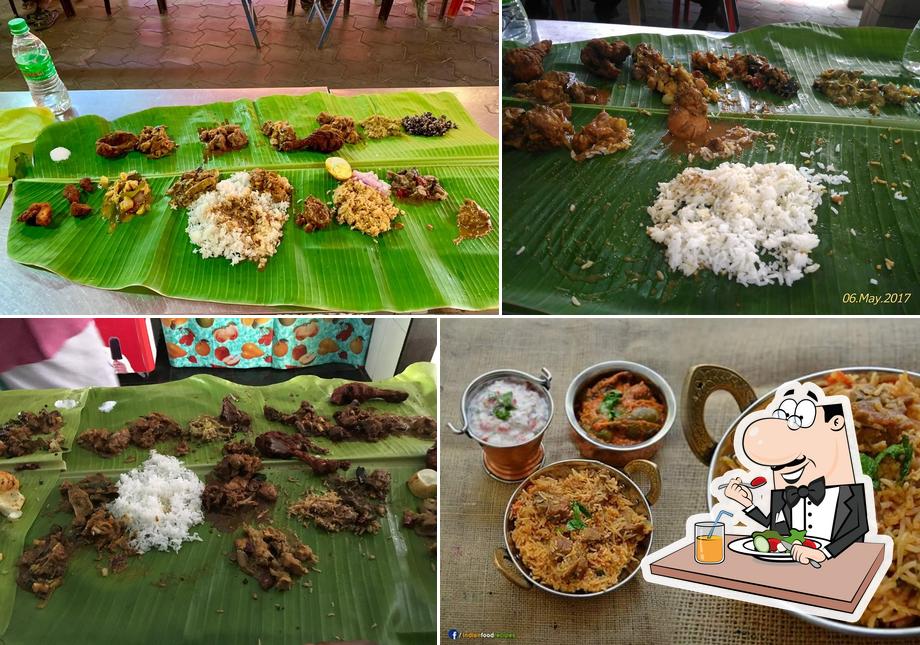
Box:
xmin=447 ymin=367 xmax=554 ymax=482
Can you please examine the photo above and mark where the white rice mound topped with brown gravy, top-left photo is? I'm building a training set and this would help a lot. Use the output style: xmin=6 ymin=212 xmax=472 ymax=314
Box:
xmin=185 ymin=172 xmax=290 ymax=269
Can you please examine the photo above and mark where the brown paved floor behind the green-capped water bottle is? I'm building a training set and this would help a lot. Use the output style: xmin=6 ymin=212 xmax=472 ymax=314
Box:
xmin=0 ymin=0 xmax=499 ymax=91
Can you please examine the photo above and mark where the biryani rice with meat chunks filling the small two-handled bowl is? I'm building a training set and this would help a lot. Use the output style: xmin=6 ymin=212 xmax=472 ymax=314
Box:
xmin=511 ymin=467 xmax=652 ymax=593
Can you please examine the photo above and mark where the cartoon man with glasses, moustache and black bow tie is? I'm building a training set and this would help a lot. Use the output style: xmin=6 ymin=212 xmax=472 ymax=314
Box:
xmin=724 ymin=381 xmax=872 ymax=564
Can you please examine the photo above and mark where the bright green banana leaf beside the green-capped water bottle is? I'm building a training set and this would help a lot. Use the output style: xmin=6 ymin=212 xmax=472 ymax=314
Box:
xmin=7 ymin=93 xmax=498 ymax=312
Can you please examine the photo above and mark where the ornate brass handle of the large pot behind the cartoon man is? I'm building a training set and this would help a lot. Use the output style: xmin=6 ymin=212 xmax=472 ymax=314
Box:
xmin=681 ymin=365 xmax=757 ymax=466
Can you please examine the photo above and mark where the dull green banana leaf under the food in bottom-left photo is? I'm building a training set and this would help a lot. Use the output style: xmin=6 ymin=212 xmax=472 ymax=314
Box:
xmin=0 ymin=364 xmax=437 ymax=645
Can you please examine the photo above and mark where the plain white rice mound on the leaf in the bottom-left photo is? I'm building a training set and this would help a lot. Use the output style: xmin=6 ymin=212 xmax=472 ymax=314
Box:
xmin=109 ymin=450 xmax=204 ymax=553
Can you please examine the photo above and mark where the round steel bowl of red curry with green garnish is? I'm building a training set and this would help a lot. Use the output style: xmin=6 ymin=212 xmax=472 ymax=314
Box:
xmin=565 ymin=361 xmax=677 ymax=466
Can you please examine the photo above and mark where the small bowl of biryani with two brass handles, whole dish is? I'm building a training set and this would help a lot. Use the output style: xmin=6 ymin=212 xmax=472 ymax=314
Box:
xmin=493 ymin=459 xmax=661 ymax=598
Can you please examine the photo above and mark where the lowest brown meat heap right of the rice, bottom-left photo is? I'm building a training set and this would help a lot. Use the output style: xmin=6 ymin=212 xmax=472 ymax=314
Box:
xmin=232 ymin=526 xmax=319 ymax=591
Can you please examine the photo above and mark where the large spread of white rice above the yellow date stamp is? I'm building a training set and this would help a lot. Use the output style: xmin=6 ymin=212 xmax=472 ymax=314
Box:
xmin=646 ymin=162 xmax=849 ymax=286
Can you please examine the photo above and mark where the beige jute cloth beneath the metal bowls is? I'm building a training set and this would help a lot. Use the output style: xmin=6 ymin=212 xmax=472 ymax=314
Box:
xmin=440 ymin=318 xmax=920 ymax=645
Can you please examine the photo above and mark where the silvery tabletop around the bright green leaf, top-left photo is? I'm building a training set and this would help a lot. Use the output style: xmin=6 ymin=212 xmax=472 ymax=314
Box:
xmin=0 ymin=86 xmax=499 ymax=316
